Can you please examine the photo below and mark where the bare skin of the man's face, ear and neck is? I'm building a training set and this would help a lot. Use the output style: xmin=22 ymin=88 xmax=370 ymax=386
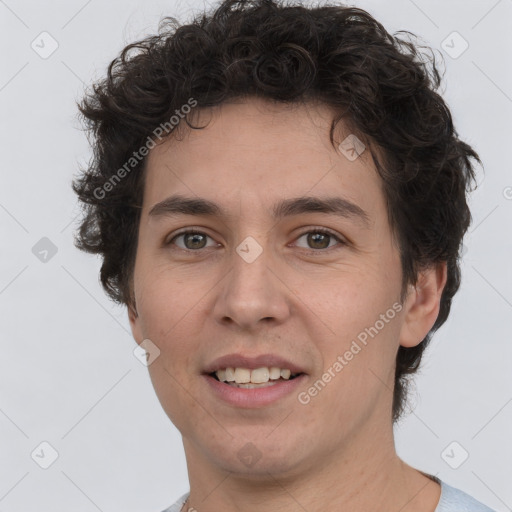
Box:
xmin=129 ymin=98 xmax=446 ymax=512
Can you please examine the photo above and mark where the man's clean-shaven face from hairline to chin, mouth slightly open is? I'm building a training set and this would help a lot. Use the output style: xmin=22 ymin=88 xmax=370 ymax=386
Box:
xmin=130 ymin=99 xmax=435 ymax=475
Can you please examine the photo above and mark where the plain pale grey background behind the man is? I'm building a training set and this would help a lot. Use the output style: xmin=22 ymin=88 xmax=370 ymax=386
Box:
xmin=0 ymin=0 xmax=512 ymax=512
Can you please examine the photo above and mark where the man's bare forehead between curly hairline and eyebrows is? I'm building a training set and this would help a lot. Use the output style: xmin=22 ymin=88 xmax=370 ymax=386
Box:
xmin=143 ymin=99 xmax=384 ymax=224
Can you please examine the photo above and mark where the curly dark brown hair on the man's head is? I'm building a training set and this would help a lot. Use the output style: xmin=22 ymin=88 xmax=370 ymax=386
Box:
xmin=73 ymin=0 xmax=481 ymax=422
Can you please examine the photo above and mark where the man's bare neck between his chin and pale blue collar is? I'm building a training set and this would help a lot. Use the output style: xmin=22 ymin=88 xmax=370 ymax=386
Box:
xmin=180 ymin=416 xmax=440 ymax=512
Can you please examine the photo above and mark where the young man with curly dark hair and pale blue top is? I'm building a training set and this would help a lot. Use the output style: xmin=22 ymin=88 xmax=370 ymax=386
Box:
xmin=74 ymin=0 xmax=490 ymax=512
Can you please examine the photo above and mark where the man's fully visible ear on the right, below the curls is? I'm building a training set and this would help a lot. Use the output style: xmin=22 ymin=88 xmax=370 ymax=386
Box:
xmin=400 ymin=261 xmax=447 ymax=347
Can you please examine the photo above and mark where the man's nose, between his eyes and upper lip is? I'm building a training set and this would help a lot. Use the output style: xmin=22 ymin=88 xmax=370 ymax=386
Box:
xmin=213 ymin=241 xmax=291 ymax=331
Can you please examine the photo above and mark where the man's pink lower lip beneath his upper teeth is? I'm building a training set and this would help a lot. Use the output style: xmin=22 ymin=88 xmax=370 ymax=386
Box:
xmin=204 ymin=374 xmax=307 ymax=409
